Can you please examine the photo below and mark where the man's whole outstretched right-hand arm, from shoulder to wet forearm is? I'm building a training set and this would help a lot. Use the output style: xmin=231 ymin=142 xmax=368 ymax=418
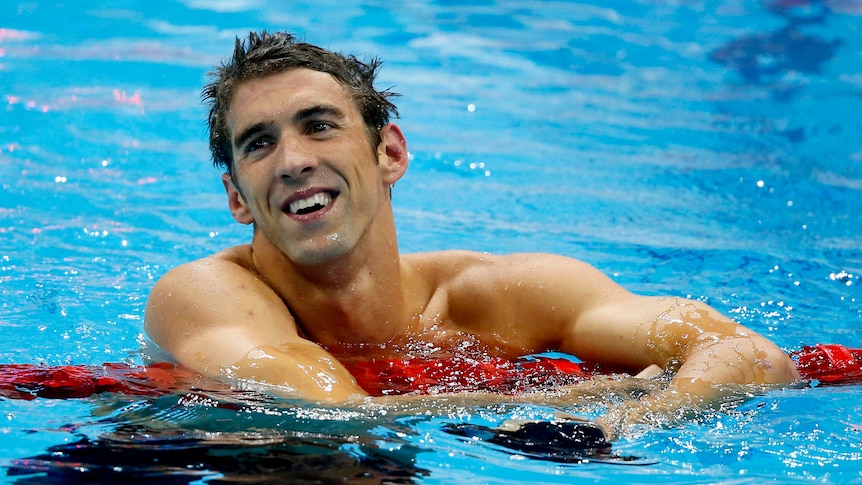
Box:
xmin=452 ymin=254 xmax=799 ymax=424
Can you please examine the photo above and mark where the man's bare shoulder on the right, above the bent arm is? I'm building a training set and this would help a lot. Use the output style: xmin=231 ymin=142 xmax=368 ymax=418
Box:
xmin=404 ymin=251 xmax=625 ymax=351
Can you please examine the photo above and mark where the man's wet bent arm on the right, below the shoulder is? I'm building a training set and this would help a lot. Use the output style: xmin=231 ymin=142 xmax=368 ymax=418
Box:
xmin=568 ymin=291 xmax=799 ymax=429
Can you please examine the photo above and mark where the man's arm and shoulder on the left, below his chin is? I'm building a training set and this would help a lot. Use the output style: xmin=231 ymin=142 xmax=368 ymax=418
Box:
xmin=145 ymin=257 xmax=365 ymax=402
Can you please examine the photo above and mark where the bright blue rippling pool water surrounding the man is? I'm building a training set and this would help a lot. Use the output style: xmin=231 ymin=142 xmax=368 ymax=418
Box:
xmin=0 ymin=0 xmax=862 ymax=484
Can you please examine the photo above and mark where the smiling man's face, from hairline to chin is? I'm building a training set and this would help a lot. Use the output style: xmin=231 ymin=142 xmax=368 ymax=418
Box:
xmin=225 ymin=69 xmax=394 ymax=264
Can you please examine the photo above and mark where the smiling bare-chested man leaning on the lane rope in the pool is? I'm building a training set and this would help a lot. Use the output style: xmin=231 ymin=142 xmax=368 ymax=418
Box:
xmin=145 ymin=32 xmax=798 ymax=428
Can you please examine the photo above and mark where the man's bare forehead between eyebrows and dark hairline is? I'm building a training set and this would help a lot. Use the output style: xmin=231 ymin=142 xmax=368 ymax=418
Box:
xmin=227 ymin=68 xmax=358 ymax=133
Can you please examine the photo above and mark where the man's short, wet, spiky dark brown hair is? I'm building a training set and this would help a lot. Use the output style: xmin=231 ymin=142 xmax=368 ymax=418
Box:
xmin=201 ymin=30 xmax=398 ymax=175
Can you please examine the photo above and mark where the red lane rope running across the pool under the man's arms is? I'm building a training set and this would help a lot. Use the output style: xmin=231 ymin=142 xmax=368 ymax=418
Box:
xmin=0 ymin=344 xmax=862 ymax=400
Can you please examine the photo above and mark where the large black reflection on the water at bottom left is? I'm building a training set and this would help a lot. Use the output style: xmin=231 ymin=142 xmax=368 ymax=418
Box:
xmin=7 ymin=426 xmax=428 ymax=485
